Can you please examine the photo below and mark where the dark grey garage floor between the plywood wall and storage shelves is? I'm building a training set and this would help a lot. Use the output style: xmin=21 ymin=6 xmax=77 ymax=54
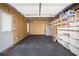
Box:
xmin=2 ymin=35 xmax=75 ymax=56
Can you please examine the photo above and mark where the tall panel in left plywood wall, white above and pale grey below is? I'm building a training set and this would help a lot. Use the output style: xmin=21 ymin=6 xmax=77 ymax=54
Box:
xmin=0 ymin=11 xmax=13 ymax=52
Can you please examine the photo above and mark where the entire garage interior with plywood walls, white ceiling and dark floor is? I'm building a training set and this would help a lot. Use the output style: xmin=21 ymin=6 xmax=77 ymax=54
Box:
xmin=0 ymin=3 xmax=79 ymax=56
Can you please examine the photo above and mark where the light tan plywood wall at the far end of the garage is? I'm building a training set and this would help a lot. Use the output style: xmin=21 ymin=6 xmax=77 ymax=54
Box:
xmin=30 ymin=21 xmax=46 ymax=35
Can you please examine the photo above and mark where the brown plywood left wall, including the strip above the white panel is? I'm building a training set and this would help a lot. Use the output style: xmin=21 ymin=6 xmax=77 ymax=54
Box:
xmin=0 ymin=3 xmax=28 ymax=44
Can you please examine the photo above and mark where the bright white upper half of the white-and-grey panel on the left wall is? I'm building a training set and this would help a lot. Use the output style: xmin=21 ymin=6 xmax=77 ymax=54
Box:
xmin=1 ymin=12 xmax=11 ymax=32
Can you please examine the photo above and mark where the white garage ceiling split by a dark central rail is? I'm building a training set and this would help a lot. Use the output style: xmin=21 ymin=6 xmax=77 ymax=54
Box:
xmin=10 ymin=3 xmax=71 ymax=17
